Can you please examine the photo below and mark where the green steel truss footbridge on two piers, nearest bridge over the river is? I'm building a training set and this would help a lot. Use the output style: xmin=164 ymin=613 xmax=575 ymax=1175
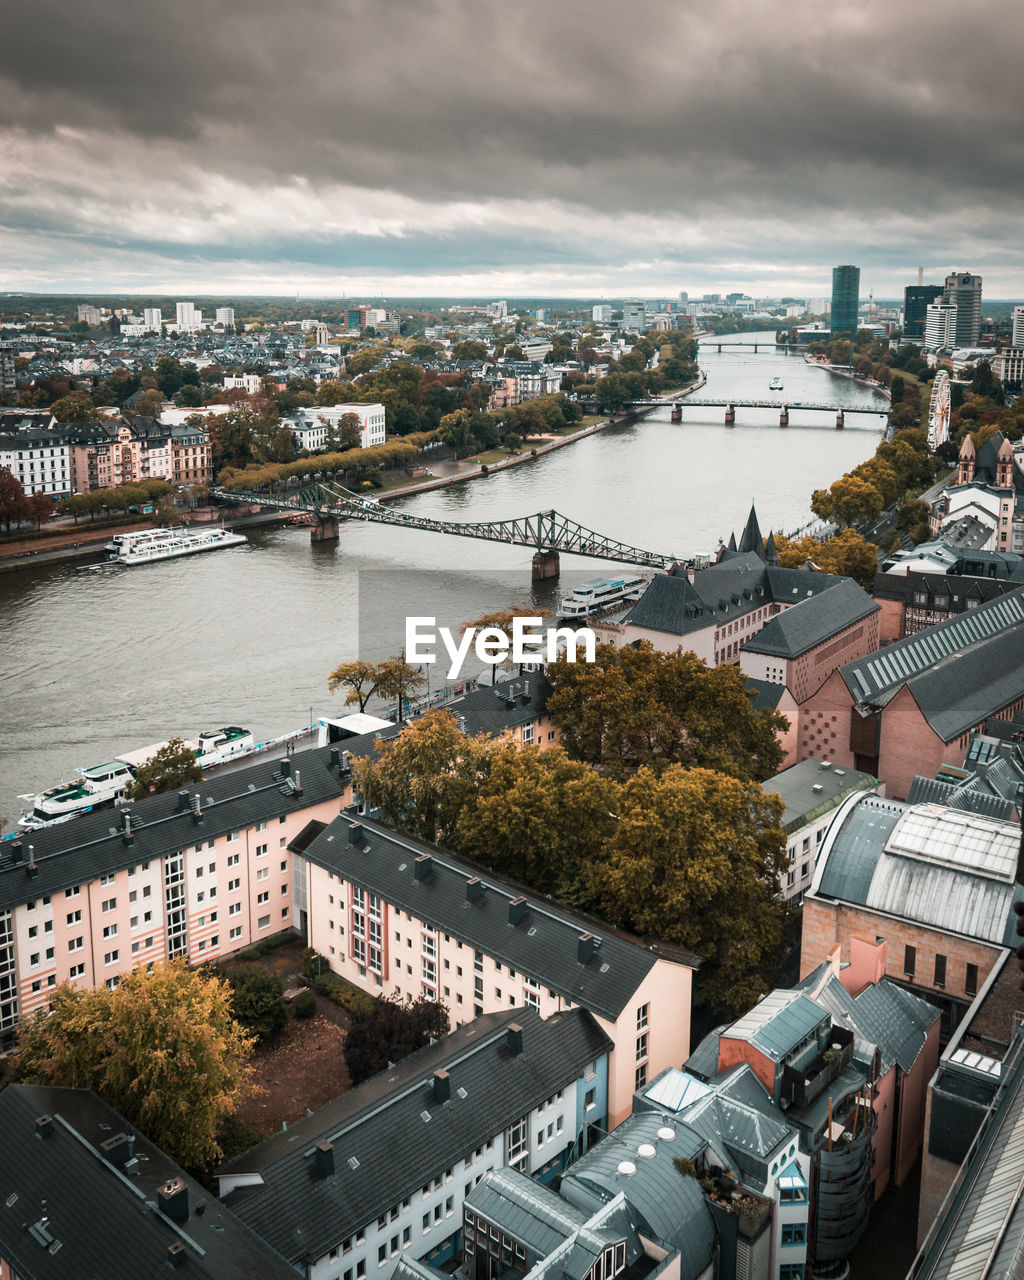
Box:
xmin=212 ymin=484 xmax=680 ymax=580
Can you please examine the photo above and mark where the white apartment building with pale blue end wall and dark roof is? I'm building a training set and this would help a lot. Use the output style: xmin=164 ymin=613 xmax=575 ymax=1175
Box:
xmin=216 ymin=1007 xmax=611 ymax=1280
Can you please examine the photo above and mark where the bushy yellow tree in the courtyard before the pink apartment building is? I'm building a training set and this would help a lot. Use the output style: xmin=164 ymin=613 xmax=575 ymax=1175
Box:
xmin=18 ymin=961 xmax=252 ymax=1169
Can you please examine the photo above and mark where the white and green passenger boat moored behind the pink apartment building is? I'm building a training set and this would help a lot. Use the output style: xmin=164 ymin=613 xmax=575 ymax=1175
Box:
xmin=18 ymin=724 xmax=256 ymax=829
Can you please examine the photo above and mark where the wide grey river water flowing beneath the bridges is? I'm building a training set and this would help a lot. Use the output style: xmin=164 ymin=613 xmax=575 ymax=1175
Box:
xmin=0 ymin=334 xmax=887 ymax=824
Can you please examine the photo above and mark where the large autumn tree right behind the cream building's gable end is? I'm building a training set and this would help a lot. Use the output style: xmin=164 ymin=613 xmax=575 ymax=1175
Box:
xmin=588 ymin=764 xmax=786 ymax=1016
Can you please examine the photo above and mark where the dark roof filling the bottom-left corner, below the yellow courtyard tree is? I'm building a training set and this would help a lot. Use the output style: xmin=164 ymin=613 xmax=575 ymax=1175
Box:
xmin=0 ymin=1084 xmax=294 ymax=1280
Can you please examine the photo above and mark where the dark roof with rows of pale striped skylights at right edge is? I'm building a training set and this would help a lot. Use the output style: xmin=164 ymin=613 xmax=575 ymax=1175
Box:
xmin=840 ymin=590 xmax=1024 ymax=742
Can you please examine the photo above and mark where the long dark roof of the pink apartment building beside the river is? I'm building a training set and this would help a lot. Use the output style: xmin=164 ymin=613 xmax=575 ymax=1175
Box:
xmin=0 ymin=748 xmax=348 ymax=910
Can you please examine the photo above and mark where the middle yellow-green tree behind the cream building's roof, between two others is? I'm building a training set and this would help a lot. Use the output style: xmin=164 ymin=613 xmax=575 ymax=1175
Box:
xmin=456 ymin=740 xmax=621 ymax=902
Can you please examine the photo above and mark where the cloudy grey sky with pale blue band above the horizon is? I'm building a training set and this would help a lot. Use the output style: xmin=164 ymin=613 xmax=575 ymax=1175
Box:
xmin=0 ymin=0 xmax=1024 ymax=298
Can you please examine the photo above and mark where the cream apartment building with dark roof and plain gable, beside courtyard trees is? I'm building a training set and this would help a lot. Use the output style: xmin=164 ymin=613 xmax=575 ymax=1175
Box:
xmin=291 ymin=813 xmax=700 ymax=1126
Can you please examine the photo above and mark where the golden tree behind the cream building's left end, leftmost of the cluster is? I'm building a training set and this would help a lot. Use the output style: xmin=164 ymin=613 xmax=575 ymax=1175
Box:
xmin=352 ymin=710 xmax=493 ymax=845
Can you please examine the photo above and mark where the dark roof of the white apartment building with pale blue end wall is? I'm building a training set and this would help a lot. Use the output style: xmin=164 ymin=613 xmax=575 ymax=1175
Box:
xmin=218 ymin=1007 xmax=611 ymax=1261
